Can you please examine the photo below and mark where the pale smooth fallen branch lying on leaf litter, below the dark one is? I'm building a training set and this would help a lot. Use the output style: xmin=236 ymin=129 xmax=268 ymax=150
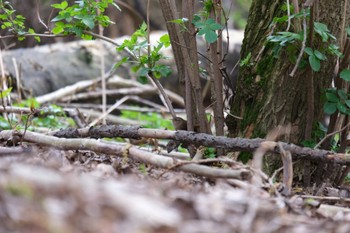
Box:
xmin=0 ymin=130 xmax=252 ymax=180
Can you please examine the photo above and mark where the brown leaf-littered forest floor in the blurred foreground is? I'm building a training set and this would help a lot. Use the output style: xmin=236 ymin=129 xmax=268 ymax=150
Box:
xmin=0 ymin=142 xmax=350 ymax=233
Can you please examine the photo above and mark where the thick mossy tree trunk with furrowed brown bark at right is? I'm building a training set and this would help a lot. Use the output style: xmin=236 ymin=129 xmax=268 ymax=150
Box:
xmin=226 ymin=0 xmax=349 ymax=182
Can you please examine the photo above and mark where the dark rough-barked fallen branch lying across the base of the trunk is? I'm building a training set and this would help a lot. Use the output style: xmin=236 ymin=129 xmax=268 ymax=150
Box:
xmin=54 ymin=125 xmax=350 ymax=165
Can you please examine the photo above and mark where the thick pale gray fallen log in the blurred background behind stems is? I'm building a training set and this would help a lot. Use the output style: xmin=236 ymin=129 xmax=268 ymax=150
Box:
xmin=2 ymin=30 xmax=243 ymax=97
